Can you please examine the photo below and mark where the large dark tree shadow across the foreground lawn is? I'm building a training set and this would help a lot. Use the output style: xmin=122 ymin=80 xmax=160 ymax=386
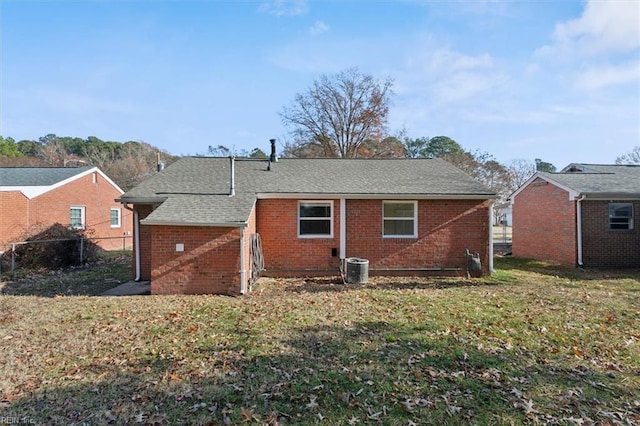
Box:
xmin=0 ymin=321 xmax=640 ymax=425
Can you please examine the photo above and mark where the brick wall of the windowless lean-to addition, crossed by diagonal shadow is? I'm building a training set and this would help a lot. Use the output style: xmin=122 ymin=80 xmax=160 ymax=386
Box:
xmin=150 ymin=225 xmax=240 ymax=295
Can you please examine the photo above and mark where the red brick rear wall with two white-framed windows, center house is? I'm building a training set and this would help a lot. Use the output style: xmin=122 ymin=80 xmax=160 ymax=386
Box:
xmin=257 ymin=200 xmax=489 ymax=276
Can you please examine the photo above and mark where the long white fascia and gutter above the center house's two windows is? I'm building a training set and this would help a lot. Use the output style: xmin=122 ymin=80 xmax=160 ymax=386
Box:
xmin=256 ymin=192 xmax=498 ymax=200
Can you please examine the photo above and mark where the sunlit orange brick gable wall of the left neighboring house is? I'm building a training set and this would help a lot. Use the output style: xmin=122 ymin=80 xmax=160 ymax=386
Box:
xmin=0 ymin=173 xmax=133 ymax=250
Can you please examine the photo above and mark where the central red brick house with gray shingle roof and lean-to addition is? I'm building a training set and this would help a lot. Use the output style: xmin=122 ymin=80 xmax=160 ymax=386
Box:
xmin=119 ymin=147 xmax=495 ymax=295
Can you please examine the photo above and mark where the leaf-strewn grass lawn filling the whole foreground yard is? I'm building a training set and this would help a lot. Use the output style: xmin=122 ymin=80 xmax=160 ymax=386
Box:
xmin=0 ymin=258 xmax=640 ymax=425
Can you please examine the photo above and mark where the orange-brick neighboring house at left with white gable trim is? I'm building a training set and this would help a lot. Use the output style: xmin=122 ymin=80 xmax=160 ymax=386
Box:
xmin=0 ymin=167 xmax=132 ymax=251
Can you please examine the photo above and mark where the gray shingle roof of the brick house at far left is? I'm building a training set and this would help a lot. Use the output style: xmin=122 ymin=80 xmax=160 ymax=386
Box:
xmin=0 ymin=167 xmax=91 ymax=186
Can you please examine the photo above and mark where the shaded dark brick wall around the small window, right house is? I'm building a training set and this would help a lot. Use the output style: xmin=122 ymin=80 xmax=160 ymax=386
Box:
xmin=581 ymin=200 xmax=640 ymax=268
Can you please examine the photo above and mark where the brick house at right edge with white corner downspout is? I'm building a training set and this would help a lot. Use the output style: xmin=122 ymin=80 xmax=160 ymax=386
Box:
xmin=510 ymin=164 xmax=640 ymax=267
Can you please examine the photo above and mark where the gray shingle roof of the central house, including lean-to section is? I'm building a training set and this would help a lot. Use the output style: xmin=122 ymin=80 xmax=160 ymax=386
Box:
xmin=120 ymin=157 xmax=495 ymax=224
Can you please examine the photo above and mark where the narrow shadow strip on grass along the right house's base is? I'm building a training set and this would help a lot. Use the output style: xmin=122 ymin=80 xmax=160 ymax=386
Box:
xmin=494 ymin=256 xmax=640 ymax=280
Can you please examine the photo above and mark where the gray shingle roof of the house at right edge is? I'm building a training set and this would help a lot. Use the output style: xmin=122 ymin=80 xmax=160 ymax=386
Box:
xmin=540 ymin=164 xmax=640 ymax=197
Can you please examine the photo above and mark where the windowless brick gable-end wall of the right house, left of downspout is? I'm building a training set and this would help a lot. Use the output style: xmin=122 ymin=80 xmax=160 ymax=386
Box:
xmin=512 ymin=181 xmax=577 ymax=266
